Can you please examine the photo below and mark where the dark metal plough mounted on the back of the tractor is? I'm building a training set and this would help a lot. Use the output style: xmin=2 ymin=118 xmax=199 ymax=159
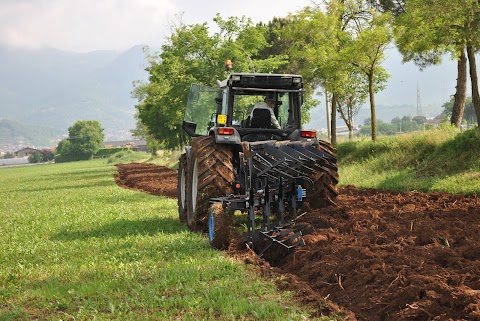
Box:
xmin=208 ymin=141 xmax=336 ymax=256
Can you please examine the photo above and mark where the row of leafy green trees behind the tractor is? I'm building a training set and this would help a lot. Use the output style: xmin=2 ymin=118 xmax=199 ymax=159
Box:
xmin=133 ymin=0 xmax=480 ymax=148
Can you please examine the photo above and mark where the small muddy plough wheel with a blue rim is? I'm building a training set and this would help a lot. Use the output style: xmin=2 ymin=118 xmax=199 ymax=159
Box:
xmin=208 ymin=202 xmax=233 ymax=250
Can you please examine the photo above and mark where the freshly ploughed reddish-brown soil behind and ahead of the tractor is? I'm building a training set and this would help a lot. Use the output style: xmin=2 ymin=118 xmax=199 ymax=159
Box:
xmin=116 ymin=164 xmax=480 ymax=321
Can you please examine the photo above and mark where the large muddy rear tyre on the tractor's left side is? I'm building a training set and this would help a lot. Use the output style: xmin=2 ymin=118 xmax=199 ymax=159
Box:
xmin=187 ymin=136 xmax=235 ymax=231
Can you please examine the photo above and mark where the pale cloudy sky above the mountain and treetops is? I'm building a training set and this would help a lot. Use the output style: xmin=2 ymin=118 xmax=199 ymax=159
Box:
xmin=0 ymin=0 xmax=310 ymax=52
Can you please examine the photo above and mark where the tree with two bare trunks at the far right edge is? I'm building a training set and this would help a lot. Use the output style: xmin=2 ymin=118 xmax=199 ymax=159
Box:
xmin=395 ymin=0 xmax=480 ymax=127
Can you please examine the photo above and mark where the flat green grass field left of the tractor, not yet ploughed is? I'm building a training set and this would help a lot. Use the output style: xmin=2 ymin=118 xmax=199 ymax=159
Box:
xmin=0 ymin=160 xmax=324 ymax=320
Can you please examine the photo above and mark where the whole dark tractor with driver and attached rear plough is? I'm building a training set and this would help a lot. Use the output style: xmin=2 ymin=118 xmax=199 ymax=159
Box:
xmin=178 ymin=69 xmax=338 ymax=255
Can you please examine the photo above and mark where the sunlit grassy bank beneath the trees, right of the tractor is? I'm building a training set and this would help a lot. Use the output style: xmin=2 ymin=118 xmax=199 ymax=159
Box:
xmin=337 ymin=126 xmax=480 ymax=194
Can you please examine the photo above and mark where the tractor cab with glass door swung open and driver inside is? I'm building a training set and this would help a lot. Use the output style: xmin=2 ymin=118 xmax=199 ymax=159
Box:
xmin=183 ymin=73 xmax=314 ymax=144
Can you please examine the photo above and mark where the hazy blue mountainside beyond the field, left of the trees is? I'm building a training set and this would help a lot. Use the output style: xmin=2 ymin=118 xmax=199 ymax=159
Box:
xmin=0 ymin=46 xmax=146 ymax=145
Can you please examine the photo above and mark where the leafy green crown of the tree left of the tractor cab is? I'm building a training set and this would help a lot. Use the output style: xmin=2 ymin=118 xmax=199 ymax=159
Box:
xmin=134 ymin=15 xmax=284 ymax=149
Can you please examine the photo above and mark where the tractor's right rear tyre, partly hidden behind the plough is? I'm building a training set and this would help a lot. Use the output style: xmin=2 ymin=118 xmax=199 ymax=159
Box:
xmin=307 ymin=140 xmax=338 ymax=209
